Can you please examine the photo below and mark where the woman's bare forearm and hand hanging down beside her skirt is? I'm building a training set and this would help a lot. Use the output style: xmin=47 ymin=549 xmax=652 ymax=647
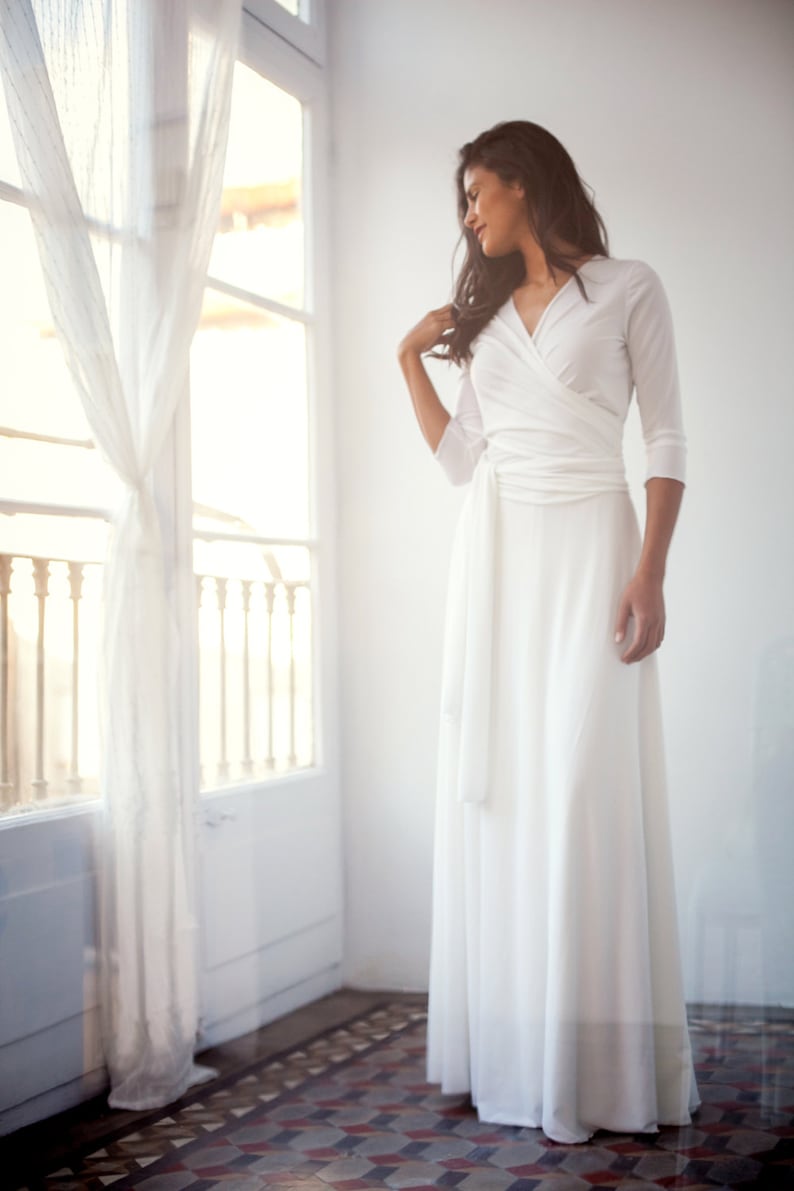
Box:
xmin=614 ymin=475 xmax=683 ymax=662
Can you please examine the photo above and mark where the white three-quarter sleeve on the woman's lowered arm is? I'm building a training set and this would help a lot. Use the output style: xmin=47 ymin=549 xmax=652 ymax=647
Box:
xmin=626 ymin=261 xmax=687 ymax=484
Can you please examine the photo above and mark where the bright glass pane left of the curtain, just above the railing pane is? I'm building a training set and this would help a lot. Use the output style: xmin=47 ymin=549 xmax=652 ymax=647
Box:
xmin=0 ymin=202 xmax=120 ymax=509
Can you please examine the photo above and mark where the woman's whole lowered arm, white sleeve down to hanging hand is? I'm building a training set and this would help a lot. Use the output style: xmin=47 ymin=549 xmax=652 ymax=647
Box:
xmin=614 ymin=261 xmax=687 ymax=662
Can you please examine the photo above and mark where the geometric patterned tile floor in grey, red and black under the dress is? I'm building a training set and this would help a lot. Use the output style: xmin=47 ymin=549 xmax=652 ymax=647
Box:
xmin=15 ymin=1003 xmax=794 ymax=1191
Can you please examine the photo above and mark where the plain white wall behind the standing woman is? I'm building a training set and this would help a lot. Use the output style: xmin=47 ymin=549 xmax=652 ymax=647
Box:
xmin=329 ymin=0 xmax=794 ymax=1005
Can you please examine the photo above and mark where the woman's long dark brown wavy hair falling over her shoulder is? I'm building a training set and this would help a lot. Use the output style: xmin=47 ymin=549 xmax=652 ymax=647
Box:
xmin=425 ymin=120 xmax=609 ymax=364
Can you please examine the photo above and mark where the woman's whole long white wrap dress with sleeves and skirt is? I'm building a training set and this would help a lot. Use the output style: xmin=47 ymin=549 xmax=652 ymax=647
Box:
xmin=426 ymin=255 xmax=700 ymax=1142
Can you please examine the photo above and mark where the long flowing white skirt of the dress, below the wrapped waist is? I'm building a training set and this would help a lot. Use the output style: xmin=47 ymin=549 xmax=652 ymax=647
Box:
xmin=427 ymin=491 xmax=699 ymax=1142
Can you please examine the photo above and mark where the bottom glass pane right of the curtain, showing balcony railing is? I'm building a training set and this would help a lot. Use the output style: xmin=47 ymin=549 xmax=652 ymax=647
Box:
xmin=193 ymin=540 xmax=314 ymax=790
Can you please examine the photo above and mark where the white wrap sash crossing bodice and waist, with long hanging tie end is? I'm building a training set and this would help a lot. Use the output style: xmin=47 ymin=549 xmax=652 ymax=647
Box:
xmin=442 ymin=304 xmax=629 ymax=803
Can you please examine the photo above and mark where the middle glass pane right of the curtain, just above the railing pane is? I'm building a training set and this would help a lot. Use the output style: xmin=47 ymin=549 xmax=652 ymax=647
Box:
xmin=190 ymin=289 xmax=310 ymax=538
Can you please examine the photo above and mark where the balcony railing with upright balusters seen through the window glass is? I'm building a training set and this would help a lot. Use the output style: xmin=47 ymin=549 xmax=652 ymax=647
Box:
xmin=0 ymin=550 xmax=314 ymax=813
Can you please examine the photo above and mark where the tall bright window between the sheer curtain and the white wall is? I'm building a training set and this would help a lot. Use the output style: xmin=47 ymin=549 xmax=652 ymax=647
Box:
xmin=190 ymin=53 xmax=314 ymax=788
